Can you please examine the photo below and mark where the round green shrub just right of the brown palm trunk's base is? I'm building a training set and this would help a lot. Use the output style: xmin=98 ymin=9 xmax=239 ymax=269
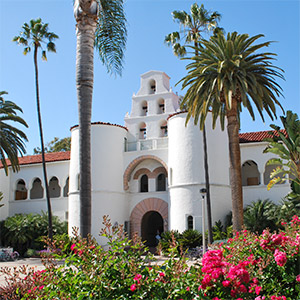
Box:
xmin=244 ymin=199 xmax=277 ymax=234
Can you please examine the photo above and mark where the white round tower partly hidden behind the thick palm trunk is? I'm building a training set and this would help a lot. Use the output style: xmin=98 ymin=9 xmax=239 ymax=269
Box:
xmin=69 ymin=123 xmax=129 ymax=244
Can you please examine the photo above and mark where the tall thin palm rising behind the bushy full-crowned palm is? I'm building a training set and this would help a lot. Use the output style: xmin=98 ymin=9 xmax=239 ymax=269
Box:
xmin=165 ymin=3 xmax=222 ymax=243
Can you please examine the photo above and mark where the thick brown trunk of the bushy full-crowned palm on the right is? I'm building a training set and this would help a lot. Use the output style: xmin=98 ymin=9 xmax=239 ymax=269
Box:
xmin=226 ymin=99 xmax=244 ymax=231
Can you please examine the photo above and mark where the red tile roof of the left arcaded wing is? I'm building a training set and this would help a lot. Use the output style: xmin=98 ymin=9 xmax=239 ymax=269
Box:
xmin=0 ymin=151 xmax=70 ymax=169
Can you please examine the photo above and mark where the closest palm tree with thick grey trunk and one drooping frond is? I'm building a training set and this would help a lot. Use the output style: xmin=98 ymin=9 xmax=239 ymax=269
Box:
xmin=74 ymin=0 xmax=127 ymax=237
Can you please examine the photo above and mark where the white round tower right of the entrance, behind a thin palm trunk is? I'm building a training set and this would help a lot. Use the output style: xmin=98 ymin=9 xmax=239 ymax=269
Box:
xmin=168 ymin=113 xmax=231 ymax=232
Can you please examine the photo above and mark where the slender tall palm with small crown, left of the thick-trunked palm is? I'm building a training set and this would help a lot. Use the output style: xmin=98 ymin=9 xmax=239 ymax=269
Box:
xmin=13 ymin=18 xmax=58 ymax=240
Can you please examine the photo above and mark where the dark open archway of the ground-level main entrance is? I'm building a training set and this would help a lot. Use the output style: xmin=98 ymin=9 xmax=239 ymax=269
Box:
xmin=141 ymin=211 xmax=164 ymax=247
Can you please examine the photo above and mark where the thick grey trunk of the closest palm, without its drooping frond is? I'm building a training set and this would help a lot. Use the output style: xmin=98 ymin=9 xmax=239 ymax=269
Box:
xmin=74 ymin=1 xmax=96 ymax=238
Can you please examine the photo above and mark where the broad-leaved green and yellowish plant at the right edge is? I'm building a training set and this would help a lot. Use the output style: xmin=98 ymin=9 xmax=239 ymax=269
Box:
xmin=264 ymin=110 xmax=300 ymax=200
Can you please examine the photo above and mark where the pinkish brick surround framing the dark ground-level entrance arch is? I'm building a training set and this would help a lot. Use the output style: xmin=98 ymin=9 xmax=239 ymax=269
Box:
xmin=130 ymin=198 xmax=168 ymax=237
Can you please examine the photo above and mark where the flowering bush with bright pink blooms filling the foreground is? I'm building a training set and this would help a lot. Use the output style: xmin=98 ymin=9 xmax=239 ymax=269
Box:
xmin=0 ymin=216 xmax=300 ymax=300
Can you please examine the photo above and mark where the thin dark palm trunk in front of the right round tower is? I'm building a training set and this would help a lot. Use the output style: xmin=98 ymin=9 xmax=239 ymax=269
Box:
xmin=203 ymin=125 xmax=213 ymax=244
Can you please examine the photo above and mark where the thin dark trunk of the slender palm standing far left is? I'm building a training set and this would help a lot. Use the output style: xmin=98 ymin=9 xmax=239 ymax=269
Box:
xmin=33 ymin=45 xmax=53 ymax=241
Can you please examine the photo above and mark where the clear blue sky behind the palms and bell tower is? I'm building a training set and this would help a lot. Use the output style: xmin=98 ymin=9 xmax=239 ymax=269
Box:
xmin=0 ymin=0 xmax=300 ymax=154
